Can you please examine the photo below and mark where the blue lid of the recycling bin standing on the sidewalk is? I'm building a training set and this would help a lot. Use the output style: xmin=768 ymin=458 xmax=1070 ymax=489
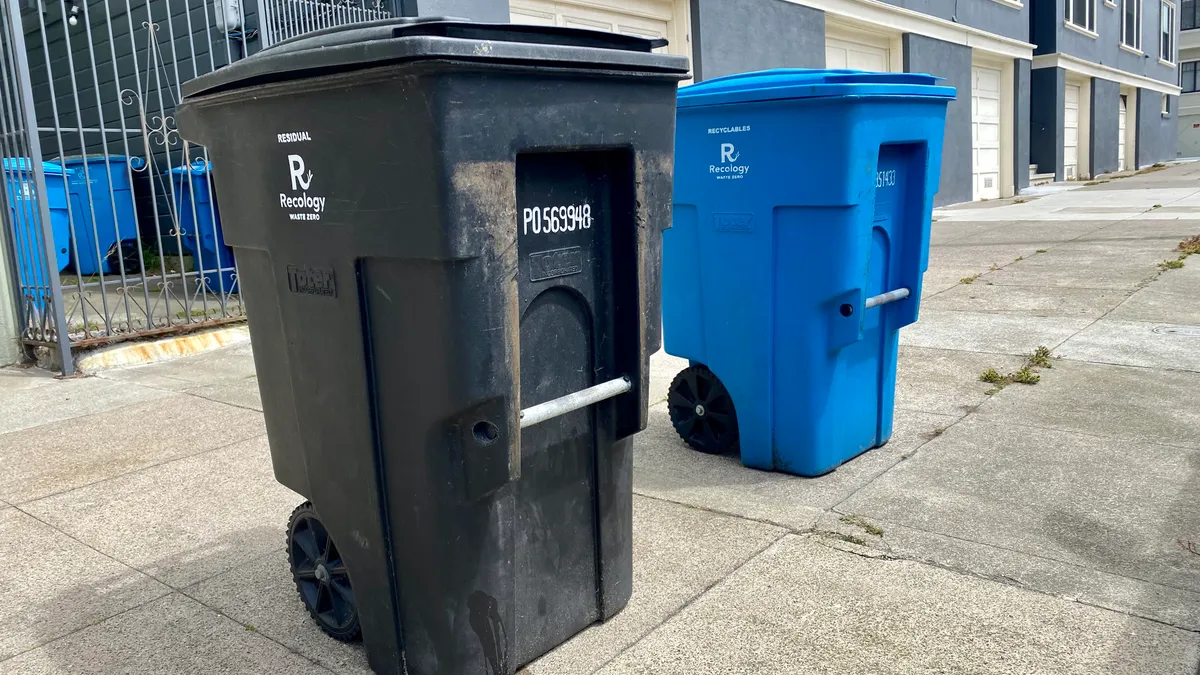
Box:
xmin=679 ymin=68 xmax=954 ymax=108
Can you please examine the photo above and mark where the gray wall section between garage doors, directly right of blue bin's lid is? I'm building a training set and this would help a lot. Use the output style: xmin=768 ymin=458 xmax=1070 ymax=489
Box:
xmin=902 ymin=32 xmax=974 ymax=205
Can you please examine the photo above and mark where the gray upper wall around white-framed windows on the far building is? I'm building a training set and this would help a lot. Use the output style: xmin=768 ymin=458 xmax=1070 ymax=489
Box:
xmin=1031 ymin=0 xmax=1180 ymax=84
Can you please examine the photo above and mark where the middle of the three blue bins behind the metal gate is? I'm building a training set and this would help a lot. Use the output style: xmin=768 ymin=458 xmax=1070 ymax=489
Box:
xmin=62 ymin=155 xmax=143 ymax=276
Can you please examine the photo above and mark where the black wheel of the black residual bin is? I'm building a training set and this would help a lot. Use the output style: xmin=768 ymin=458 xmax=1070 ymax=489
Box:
xmin=288 ymin=502 xmax=362 ymax=643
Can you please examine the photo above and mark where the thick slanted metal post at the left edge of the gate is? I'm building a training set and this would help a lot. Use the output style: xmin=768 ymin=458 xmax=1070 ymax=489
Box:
xmin=5 ymin=2 xmax=74 ymax=375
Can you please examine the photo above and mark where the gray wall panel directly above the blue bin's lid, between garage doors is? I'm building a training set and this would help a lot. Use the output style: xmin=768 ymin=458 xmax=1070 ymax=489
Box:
xmin=691 ymin=0 xmax=825 ymax=82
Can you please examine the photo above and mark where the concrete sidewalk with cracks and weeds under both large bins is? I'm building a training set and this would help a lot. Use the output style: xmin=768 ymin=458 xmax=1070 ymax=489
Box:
xmin=7 ymin=165 xmax=1200 ymax=675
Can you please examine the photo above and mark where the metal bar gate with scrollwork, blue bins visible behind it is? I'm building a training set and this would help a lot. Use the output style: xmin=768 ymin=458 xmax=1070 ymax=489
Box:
xmin=0 ymin=0 xmax=391 ymax=374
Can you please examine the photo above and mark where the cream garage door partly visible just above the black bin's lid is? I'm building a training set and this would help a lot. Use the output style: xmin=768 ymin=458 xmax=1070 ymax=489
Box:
xmin=509 ymin=0 xmax=691 ymax=56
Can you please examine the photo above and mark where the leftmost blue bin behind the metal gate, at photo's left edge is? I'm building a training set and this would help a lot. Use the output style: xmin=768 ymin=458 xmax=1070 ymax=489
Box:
xmin=4 ymin=157 xmax=71 ymax=287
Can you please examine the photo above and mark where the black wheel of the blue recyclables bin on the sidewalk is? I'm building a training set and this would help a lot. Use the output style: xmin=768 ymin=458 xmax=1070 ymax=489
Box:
xmin=667 ymin=365 xmax=738 ymax=455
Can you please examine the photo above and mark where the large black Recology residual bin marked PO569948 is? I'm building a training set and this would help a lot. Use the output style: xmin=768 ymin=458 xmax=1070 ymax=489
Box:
xmin=178 ymin=19 xmax=688 ymax=675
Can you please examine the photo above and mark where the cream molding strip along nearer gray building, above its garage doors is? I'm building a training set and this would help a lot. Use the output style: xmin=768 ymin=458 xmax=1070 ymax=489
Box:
xmin=786 ymin=0 xmax=1033 ymax=59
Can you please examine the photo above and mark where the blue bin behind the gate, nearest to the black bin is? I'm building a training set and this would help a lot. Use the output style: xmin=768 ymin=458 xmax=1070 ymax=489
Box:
xmin=170 ymin=160 xmax=238 ymax=293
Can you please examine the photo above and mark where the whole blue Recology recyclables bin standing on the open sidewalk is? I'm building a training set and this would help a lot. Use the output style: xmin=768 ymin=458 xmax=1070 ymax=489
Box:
xmin=662 ymin=70 xmax=954 ymax=476
